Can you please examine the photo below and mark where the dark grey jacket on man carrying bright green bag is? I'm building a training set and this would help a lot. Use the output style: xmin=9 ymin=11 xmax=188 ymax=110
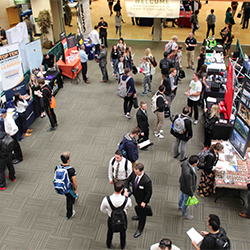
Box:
xmin=179 ymin=161 xmax=197 ymax=196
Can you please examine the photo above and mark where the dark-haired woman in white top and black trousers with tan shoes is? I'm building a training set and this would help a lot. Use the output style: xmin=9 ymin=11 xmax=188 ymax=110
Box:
xmin=14 ymin=92 xmax=33 ymax=139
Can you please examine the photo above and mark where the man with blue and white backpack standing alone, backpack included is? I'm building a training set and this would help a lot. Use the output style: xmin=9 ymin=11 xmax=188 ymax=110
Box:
xmin=53 ymin=152 xmax=78 ymax=219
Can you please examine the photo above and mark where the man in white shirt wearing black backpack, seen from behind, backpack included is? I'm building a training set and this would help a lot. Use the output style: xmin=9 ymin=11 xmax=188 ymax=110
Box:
xmin=100 ymin=181 xmax=132 ymax=249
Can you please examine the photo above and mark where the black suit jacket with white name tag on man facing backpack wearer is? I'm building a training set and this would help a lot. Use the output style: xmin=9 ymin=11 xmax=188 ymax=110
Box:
xmin=124 ymin=171 xmax=153 ymax=205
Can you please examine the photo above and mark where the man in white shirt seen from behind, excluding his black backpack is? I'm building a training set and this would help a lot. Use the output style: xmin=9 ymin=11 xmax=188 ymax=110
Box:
xmin=100 ymin=181 xmax=132 ymax=249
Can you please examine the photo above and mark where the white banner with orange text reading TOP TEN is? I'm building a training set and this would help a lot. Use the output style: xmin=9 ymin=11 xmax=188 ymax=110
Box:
xmin=0 ymin=43 xmax=24 ymax=91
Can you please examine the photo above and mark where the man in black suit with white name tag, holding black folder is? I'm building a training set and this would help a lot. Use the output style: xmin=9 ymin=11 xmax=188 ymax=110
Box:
xmin=124 ymin=163 xmax=152 ymax=238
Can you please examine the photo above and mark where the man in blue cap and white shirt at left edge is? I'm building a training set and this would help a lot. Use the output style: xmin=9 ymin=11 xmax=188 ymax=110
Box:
xmin=0 ymin=109 xmax=23 ymax=164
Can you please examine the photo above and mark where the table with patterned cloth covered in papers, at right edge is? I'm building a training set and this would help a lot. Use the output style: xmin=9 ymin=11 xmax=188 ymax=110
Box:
xmin=212 ymin=141 xmax=250 ymax=206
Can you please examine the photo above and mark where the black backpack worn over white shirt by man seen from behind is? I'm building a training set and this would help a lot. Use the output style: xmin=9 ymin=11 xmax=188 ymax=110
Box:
xmin=107 ymin=196 xmax=128 ymax=233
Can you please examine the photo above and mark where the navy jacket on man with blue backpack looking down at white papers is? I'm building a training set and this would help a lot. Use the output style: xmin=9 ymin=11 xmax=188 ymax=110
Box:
xmin=123 ymin=133 xmax=139 ymax=162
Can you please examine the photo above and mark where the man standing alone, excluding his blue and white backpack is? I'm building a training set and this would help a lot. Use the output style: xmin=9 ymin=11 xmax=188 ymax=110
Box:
xmin=54 ymin=152 xmax=78 ymax=219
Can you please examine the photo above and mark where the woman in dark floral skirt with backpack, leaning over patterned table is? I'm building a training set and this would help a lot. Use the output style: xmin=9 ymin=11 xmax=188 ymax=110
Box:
xmin=197 ymin=142 xmax=223 ymax=197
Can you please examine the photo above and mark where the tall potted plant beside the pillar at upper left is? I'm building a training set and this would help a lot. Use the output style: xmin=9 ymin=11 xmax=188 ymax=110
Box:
xmin=37 ymin=10 xmax=52 ymax=49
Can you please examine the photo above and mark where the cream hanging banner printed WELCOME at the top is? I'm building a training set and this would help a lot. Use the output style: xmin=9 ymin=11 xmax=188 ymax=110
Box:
xmin=125 ymin=0 xmax=180 ymax=18
